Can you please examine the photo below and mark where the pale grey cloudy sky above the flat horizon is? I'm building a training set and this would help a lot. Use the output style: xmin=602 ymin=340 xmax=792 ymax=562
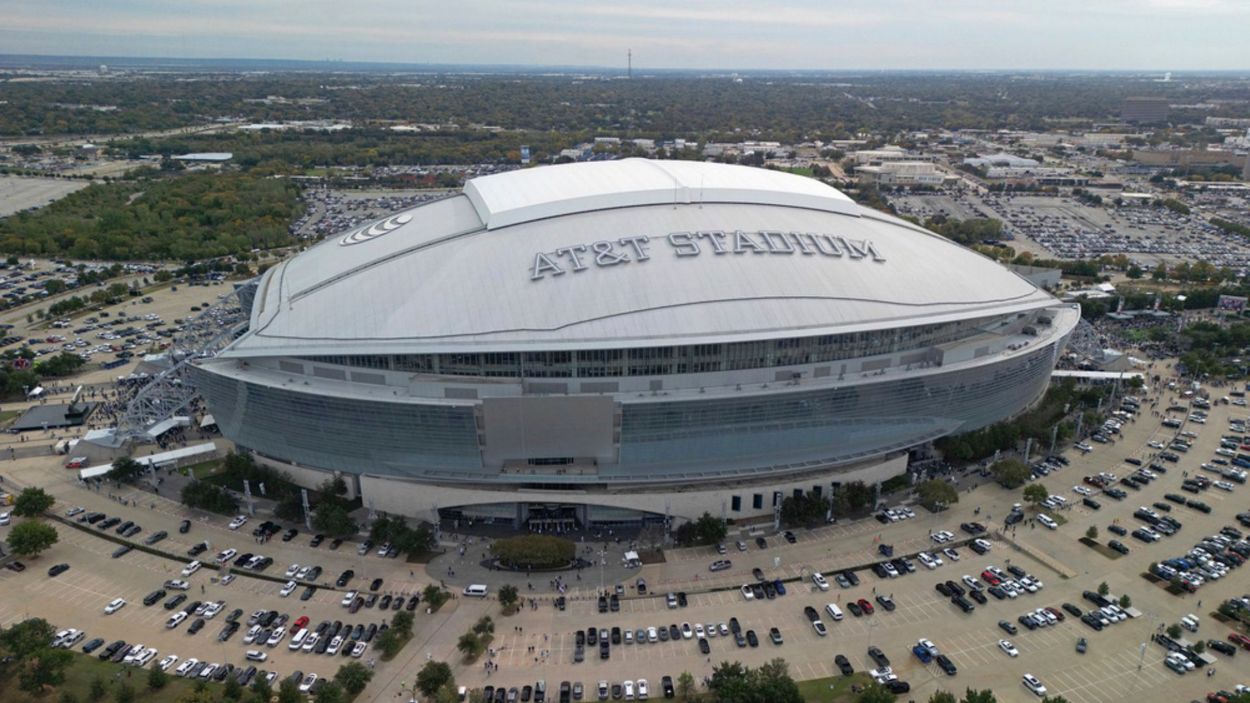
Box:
xmin=0 ymin=0 xmax=1250 ymax=70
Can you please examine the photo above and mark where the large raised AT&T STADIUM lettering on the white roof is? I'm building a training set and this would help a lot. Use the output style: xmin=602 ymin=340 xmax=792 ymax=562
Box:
xmin=530 ymin=230 xmax=885 ymax=280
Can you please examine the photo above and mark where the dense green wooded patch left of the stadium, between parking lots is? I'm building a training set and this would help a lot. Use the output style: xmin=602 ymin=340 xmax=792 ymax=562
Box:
xmin=0 ymin=173 xmax=303 ymax=260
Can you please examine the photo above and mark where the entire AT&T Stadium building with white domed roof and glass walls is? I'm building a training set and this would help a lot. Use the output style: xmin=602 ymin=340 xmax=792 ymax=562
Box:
xmin=191 ymin=159 xmax=1080 ymax=529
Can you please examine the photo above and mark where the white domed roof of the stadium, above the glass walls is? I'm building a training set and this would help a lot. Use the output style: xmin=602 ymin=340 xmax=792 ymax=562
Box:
xmin=232 ymin=160 xmax=1055 ymax=357
